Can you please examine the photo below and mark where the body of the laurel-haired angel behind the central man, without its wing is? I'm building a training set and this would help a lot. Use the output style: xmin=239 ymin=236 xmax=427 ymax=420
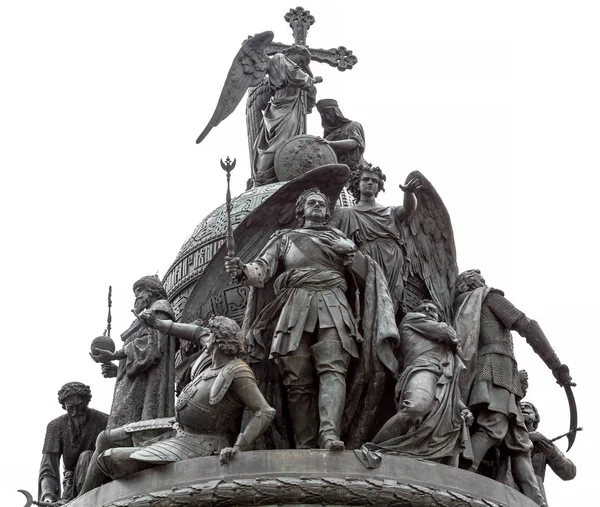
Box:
xmin=330 ymin=163 xmax=421 ymax=311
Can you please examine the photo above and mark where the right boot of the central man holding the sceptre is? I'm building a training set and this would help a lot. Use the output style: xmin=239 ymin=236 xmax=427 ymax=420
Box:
xmin=310 ymin=340 xmax=350 ymax=451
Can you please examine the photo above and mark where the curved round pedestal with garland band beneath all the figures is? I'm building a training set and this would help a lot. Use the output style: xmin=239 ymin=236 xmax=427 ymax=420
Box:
xmin=70 ymin=449 xmax=535 ymax=507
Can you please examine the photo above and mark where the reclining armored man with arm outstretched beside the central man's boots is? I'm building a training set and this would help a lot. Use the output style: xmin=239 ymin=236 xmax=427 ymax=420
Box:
xmin=79 ymin=316 xmax=275 ymax=489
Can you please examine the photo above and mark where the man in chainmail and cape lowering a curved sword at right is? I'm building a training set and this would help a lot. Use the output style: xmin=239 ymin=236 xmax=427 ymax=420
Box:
xmin=454 ymin=269 xmax=573 ymax=505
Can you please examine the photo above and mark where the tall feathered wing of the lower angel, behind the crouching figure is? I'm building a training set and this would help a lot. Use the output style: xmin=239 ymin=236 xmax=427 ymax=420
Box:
xmin=402 ymin=171 xmax=458 ymax=323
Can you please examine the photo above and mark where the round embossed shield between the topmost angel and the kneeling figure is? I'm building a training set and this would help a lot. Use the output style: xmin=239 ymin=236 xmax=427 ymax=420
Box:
xmin=275 ymin=134 xmax=337 ymax=181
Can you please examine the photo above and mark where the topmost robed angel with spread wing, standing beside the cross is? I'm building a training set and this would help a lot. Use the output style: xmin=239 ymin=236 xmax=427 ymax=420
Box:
xmin=196 ymin=32 xmax=323 ymax=185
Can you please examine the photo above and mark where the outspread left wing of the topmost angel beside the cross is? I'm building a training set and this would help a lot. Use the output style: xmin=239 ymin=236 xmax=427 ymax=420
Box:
xmin=196 ymin=32 xmax=273 ymax=144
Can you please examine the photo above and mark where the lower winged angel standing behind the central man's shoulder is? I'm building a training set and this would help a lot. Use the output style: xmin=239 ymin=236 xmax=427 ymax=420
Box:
xmin=330 ymin=163 xmax=458 ymax=322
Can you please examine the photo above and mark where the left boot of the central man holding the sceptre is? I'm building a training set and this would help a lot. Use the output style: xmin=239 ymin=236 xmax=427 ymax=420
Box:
xmin=275 ymin=355 xmax=319 ymax=449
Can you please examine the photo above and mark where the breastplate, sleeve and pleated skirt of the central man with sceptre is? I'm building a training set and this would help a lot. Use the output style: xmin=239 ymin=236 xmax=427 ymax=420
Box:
xmin=244 ymin=227 xmax=362 ymax=360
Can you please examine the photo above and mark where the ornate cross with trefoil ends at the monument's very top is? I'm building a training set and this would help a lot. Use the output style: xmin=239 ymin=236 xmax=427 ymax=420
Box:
xmin=266 ymin=7 xmax=358 ymax=133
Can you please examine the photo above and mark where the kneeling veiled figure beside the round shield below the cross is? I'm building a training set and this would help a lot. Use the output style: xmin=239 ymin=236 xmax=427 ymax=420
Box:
xmin=317 ymin=99 xmax=366 ymax=173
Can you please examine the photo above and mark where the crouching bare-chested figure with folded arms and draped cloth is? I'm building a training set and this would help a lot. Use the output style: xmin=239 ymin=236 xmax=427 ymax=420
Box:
xmin=367 ymin=300 xmax=473 ymax=464
